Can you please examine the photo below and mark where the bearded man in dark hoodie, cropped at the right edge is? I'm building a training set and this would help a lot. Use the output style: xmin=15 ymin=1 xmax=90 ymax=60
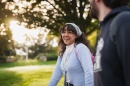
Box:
xmin=90 ymin=0 xmax=130 ymax=86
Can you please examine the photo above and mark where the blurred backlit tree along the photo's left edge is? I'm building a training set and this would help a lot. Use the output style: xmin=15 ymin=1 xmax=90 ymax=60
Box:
xmin=0 ymin=0 xmax=15 ymax=55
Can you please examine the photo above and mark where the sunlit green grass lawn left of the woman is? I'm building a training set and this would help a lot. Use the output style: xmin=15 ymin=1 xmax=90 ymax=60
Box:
xmin=0 ymin=60 xmax=63 ymax=86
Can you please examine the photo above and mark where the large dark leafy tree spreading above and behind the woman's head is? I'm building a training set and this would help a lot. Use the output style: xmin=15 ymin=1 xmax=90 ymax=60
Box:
xmin=4 ymin=0 xmax=96 ymax=35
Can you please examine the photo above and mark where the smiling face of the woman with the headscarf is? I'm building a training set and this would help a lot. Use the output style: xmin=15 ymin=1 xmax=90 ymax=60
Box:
xmin=61 ymin=26 xmax=77 ymax=46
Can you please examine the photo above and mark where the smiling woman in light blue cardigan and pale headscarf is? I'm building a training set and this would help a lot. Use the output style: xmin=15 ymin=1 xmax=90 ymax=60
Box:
xmin=48 ymin=23 xmax=93 ymax=86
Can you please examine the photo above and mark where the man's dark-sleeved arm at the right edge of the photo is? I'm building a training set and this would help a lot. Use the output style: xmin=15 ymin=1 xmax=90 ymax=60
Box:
xmin=116 ymin=14 xmax=130 ymax=86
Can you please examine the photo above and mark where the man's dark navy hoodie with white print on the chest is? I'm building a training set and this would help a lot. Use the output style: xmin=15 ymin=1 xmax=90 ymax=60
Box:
xmin=94 ymin=6 xmax=130 ymax=86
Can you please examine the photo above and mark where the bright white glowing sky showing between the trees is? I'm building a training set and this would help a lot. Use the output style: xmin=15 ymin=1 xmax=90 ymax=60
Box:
xmin=10 ymin=21 xmax=57 ymax=47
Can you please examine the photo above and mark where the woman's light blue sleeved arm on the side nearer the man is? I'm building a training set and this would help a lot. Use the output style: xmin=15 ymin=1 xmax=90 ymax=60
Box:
xmin=77 ymin=44 xmax=94 ymax=86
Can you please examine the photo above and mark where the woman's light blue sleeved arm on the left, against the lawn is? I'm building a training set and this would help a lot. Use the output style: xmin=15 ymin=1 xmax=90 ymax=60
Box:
xmin=48 ymin=57 xmax=62 ymax=86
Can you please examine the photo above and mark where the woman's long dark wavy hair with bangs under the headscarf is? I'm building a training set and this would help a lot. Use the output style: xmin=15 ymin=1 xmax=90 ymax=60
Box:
xmin=58 ymin=24 xmax=88 ymax=57
